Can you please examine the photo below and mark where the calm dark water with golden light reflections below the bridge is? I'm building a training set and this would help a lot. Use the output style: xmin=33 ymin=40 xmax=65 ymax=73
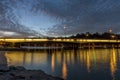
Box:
xmin=6 ymin=48 xmax=120 ymax=80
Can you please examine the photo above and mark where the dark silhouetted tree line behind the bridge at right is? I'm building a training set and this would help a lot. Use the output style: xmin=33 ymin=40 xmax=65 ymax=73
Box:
xmin=68 ymin=32 xmax=120 ymax=39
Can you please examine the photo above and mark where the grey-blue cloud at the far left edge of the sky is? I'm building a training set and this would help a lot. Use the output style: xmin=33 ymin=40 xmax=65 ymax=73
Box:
xmin=0 ymin=0 xmax=36 ymax=36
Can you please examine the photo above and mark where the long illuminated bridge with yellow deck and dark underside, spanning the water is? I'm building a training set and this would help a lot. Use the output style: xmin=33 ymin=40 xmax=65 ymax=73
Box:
xmin=0 ymin=38 xmax=120 ymax=48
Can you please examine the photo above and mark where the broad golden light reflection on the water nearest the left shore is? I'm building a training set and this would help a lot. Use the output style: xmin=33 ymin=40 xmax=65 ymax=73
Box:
xmin=6 ymin=51 xmax=47 ymax=66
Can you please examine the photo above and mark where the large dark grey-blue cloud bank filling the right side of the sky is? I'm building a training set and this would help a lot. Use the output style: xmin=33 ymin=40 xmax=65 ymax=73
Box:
xmin=36 ymin=0 xmax=120 ymax=35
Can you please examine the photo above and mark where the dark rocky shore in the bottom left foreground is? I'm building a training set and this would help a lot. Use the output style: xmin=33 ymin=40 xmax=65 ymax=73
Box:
xmin=0 ymin=66 xmax=63 ymax=80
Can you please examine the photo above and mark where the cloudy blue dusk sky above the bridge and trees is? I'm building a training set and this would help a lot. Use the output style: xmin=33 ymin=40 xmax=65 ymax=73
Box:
xmin=0 ymin=0 xmax=120 ymax=36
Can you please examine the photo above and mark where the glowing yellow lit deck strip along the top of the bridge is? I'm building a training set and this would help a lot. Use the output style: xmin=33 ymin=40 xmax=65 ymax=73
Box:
xmin=0 ymin=38 xmax=120 ymax=43
